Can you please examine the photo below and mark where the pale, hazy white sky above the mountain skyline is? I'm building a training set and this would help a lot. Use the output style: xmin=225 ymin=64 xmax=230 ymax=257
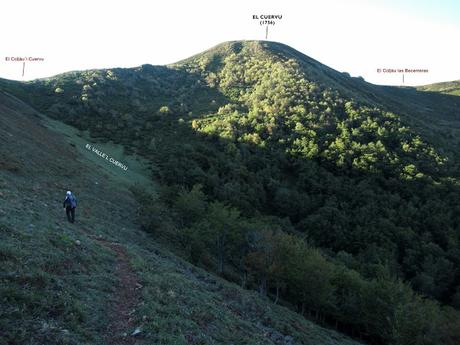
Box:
xmin=0 ymin=0 xmax=460 ymax=85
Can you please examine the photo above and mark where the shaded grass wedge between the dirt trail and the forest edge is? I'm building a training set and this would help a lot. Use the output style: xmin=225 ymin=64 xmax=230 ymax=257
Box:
xmin=126 ymin=242 xmax=362 ymax=345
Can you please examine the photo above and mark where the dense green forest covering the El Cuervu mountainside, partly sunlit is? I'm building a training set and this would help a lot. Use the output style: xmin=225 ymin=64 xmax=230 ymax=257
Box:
xmin=2 ymin=42 xmax=460 ymax=344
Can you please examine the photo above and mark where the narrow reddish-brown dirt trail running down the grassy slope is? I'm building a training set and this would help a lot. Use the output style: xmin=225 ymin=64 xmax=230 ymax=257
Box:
xmin=91 ymin=236 xmax=142 ymax=345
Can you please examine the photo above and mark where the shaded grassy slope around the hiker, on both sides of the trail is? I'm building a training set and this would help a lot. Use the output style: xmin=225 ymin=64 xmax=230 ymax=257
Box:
xmin=0 ymin=93 xmax=362 ymax=345
